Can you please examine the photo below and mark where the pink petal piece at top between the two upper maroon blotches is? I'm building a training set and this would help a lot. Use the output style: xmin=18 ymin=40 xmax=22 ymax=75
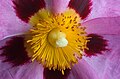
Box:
xmin=45 ymin=0 xmax=70 ymax=13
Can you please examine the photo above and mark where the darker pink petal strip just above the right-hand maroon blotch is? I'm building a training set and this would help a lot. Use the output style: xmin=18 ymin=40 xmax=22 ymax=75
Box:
xmin=82 ymin=17 xmax=120 ymax=34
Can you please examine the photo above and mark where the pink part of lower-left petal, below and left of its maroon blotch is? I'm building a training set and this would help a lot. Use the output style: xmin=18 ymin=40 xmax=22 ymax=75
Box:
xmin=0 ymin=34 xmax=43 ymax=79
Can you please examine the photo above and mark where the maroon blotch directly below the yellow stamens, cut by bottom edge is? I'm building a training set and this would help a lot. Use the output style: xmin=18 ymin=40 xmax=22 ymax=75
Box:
xmin=43 ymin=68 xmax=70 ymax=79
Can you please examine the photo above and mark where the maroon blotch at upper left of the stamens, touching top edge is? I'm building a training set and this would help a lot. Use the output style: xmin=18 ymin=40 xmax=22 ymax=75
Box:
xmin=13 ymin=0 xmax=45 ymax=22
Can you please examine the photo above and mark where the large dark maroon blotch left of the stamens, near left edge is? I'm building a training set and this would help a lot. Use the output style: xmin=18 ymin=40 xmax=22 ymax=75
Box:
xmin=0 ymin=37 xmax=30 ymax=66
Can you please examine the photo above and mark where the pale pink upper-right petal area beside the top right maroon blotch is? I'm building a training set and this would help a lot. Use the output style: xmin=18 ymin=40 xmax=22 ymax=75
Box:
xmin=88 ymin=0 xmax=120 ymax=19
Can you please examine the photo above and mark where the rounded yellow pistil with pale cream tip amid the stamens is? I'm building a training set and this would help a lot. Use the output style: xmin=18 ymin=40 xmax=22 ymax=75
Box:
xmin=48 ymin=29 xmax=68 ymax=47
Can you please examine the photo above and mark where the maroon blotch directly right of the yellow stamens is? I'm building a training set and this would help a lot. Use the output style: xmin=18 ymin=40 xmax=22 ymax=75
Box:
xmin=85 ymin=34 xmax=108 ymax=56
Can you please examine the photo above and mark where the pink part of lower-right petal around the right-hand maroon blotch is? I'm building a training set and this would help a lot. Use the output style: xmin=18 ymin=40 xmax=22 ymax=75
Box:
xmin=84 ymin=34 xmax=120 ymax=79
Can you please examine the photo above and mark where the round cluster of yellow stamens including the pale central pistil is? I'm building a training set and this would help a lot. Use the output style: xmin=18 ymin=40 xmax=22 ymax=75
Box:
xmin=25 ymin=8 xmax=88 ymax=75
